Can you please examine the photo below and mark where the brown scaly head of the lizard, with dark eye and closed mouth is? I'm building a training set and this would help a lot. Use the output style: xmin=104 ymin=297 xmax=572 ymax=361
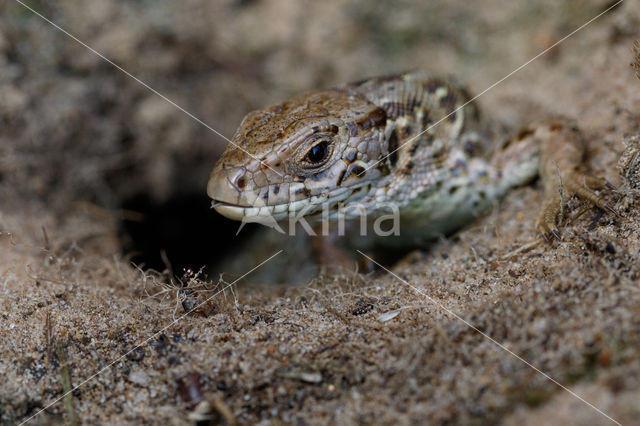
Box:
xmin=207 ymin=89 xmax=389 ymax=225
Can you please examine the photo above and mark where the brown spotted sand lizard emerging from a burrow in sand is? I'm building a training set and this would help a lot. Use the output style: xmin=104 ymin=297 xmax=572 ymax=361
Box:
xmin=207 ymin=72 xmax=617 ymax=246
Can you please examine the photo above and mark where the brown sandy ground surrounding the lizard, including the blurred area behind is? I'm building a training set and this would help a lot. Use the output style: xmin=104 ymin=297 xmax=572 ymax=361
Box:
xmin=0 ymin=0 xmax=640 ymax=425
